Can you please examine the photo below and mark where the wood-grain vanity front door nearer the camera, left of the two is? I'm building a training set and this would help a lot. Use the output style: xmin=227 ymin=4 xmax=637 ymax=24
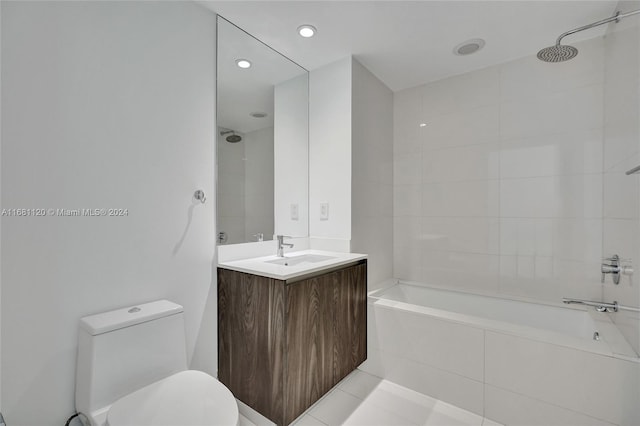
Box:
xmin=284 ymin=273 xmax=337 ymax=424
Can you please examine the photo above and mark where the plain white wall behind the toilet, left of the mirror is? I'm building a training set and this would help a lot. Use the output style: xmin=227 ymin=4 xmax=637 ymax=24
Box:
xmin=1 ymin=2 xmax=216 ymax=426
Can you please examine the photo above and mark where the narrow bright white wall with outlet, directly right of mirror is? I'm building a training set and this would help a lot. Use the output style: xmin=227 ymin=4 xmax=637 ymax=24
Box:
xmin=309 ymin=57 xmax=352 ymax=246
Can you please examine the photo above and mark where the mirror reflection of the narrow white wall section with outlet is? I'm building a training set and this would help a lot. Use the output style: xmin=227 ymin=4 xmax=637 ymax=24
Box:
xmin=273 ymin=73 xmax=310 ymax=237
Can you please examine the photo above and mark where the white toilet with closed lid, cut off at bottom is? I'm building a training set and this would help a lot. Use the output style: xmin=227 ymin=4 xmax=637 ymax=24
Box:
xmin=76 ymin=300 xmax=239 ymax=426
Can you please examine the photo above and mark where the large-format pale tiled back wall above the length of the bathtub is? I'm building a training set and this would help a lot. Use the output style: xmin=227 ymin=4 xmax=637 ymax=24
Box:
xmin=394 ymin=38 xmax=604 ymax=302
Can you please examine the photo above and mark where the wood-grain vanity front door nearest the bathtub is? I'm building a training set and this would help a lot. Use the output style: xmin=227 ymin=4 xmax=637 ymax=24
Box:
xmin=333 ymin=263 xmax=367 ymax=384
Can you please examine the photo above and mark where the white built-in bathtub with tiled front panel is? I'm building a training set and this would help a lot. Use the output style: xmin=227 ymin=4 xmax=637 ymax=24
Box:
xmin=361 ymin=282 xmax=640 ymax=425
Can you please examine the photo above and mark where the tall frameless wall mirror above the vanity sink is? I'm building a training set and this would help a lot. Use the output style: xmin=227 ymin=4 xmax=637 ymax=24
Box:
xmin=216 ymin=16 xmax=309 ymax=244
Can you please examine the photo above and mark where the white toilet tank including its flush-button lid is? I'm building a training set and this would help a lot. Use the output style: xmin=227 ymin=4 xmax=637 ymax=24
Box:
xmin=76 ymin=300 xmax=187 ymax=422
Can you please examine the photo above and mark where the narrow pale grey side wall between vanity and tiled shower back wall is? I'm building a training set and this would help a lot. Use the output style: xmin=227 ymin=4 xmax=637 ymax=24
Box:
xmin=351 ymin=59 xmax=393 ymax=290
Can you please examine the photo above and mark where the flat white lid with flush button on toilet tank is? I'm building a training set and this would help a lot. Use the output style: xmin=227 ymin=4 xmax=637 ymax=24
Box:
xmin=80 ymin=300 xmax=184 ymax=336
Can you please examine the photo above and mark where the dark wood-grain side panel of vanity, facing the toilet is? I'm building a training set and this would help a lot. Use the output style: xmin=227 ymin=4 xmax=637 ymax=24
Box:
xmin=218 ymin=269 xmax=284 ymax=424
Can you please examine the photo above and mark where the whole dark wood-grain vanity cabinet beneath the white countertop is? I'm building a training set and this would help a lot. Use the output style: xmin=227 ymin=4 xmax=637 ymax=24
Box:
xmin=218 ymin=260 xmax=367 ymax=425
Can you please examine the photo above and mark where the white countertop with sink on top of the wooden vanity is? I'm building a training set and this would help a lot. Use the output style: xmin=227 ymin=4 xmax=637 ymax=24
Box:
xmin=218 ymin=250 xmax=367 ymax=281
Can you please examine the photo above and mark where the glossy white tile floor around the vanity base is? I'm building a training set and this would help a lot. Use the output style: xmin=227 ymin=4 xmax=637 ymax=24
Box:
xmin=240 ymin=370 xmax=500 ymax=426
